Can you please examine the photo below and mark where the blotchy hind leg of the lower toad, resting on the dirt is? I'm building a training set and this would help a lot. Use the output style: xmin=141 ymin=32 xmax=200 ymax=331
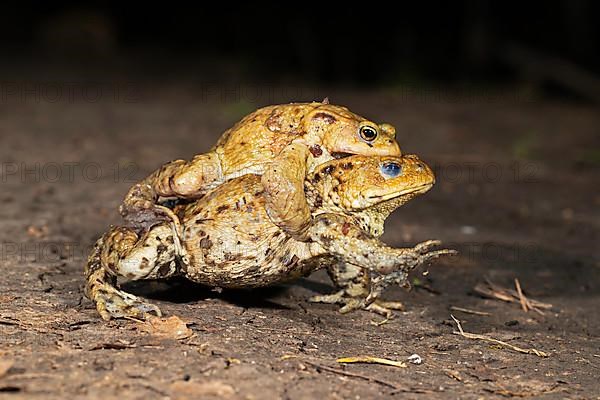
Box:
xmin=85 ymin=224 xmax=177 ymax=320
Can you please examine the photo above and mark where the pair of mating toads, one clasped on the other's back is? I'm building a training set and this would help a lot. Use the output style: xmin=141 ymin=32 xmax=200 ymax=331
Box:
xmin=85 ymin=101 xmax=453 ymax=320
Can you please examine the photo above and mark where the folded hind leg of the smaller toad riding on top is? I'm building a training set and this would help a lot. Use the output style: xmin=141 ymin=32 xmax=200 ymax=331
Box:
xmin=119 ymin=152 xmax=223 ymax=230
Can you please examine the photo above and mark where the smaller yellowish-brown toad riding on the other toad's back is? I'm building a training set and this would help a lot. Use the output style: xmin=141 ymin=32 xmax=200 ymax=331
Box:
xmin=121 ymin=101 xmax=400 ymax=240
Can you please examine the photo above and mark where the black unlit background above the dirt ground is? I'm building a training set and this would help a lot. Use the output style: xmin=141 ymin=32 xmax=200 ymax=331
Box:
xmin=0 ymin=0 xmax=600 ymax=100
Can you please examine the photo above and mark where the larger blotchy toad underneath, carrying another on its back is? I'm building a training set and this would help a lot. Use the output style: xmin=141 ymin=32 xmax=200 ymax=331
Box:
xmin=86 ymin=155 xmax=452 ymax=319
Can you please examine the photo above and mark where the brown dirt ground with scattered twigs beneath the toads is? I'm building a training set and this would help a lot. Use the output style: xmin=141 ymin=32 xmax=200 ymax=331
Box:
xmin=0 ymin=83 xmax=600 ymax=399
